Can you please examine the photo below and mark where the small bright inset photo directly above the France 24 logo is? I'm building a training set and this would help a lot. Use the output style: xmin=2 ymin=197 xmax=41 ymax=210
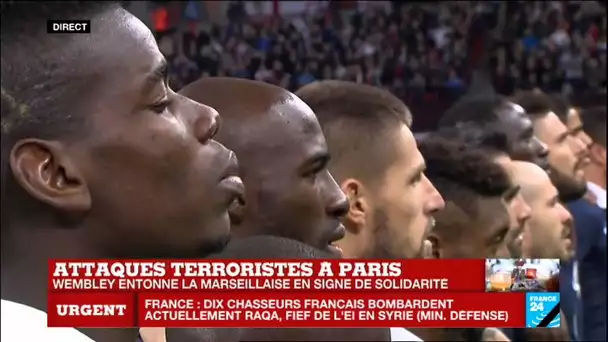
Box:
xmin=486 ymin=259 xmax=560 ymax=292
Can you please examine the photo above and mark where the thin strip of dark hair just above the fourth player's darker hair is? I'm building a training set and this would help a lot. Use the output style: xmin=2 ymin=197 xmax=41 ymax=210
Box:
xmin=434 ymin=122 xmax=511 ymax=157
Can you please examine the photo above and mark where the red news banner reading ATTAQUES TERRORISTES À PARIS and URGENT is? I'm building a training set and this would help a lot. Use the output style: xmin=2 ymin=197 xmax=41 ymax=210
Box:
xmin=48 ymin=260 xmax=525 ymax=328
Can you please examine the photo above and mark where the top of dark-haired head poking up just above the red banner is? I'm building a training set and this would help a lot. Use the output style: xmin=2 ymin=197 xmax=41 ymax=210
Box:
xmin=209 ymin=235 xmax=335 ymax=259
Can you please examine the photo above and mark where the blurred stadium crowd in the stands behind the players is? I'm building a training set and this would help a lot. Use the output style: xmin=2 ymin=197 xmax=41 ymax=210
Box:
xmin=126 ymin=0 xmax=606 ymax=131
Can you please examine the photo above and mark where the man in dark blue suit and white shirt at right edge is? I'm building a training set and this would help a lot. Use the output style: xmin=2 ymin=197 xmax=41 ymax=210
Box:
xmin=568 ymin=107 xmax=607 ymax=341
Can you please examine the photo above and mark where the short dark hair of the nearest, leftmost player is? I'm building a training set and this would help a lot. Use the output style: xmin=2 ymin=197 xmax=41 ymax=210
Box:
xmin=0 ymin=1 xmax=119 ymax=225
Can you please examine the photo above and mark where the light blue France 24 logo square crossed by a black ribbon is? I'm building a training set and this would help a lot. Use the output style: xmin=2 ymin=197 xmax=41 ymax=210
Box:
xmin=526 ymin=292 xmax=561 ymax=328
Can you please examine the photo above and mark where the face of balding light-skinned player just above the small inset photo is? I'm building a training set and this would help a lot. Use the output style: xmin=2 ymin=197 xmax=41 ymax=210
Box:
xmin=523 ymin=178 xmax=572 ymax=260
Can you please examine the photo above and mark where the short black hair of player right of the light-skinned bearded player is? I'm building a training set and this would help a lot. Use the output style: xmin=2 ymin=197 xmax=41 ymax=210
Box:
xmin=418 ymin=135 xmax=511 ymax=216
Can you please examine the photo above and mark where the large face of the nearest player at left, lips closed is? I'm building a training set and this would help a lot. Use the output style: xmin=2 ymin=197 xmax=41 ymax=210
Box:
xmin=66 ymin=9 xmax=242 ymax=257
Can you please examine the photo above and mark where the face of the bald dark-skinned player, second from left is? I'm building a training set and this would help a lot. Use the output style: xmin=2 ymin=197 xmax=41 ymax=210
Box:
xmin=226 ymin=96 xmax=348 ymax=254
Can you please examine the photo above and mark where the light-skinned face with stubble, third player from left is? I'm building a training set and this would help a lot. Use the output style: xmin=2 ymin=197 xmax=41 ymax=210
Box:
xmin=372 ymin=125 xmax=444 ymax=258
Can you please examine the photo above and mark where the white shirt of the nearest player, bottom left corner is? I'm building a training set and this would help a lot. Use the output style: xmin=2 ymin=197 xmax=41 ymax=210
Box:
xmin=0 ymin=299 xmax=95 ymax=342
